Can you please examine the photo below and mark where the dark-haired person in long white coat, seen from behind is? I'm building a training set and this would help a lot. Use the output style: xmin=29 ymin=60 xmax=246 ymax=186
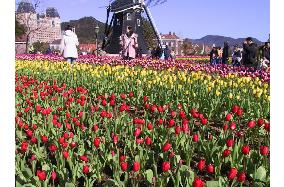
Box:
xmin=60 ymin=25 xmax=79 ymax=64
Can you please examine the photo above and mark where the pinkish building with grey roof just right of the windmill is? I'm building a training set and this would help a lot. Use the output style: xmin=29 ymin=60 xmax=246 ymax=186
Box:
xmin=161 ymin=32 xmax=183 ymax=55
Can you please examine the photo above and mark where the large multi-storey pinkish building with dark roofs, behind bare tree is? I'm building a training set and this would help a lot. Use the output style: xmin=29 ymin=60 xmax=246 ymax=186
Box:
xmin=16 ymin=0 xmax=61 ymax=44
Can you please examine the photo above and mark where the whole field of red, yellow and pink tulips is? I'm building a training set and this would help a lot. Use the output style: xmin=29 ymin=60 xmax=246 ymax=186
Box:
xmin=15 ymin=55 xmax=270 ymax=187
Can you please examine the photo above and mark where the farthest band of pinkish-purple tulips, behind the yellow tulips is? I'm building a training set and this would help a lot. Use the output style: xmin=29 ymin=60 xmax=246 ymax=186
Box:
xmin=16 ymin=55 xmax=270 ymax=82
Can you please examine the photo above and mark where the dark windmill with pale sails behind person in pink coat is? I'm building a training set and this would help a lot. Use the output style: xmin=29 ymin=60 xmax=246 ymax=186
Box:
xmin=102 ymin=0 xmax=166 ymax=54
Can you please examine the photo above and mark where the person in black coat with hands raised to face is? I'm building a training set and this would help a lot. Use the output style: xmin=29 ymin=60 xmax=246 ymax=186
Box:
xmin=243 ymin=37 xmax=257 ymax=66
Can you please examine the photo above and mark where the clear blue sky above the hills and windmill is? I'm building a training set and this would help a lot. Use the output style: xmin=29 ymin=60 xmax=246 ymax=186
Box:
xmin=16 ymin=0 xmax=270 ymax=41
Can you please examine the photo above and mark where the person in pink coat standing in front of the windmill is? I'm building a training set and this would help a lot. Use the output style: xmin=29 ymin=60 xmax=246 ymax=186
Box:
xmin=120 ymin=26 xmax=138 ymax=60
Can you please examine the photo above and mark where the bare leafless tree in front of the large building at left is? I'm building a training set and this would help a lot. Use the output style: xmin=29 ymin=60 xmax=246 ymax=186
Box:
xmin=16 ymin=0 xmax=46 ymax=53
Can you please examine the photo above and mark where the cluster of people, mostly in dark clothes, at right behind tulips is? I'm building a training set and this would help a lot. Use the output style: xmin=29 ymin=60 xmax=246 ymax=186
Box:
xmin=210 ymin=37 xmax=270 ymax=69
